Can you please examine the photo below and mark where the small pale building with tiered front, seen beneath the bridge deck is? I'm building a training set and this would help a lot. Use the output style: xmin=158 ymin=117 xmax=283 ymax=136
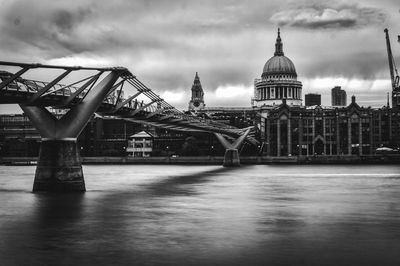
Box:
xmin=126 ymin=131 xmax=153 ymax=157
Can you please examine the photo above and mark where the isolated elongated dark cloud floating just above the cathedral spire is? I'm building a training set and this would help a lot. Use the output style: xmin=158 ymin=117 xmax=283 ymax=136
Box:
xmin=270 ymin=1 xmax=386 ymax=29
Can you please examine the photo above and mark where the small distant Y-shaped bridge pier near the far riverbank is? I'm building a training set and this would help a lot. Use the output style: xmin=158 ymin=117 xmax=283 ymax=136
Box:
xmin=214 ymin=128 xmax=251 ymax=167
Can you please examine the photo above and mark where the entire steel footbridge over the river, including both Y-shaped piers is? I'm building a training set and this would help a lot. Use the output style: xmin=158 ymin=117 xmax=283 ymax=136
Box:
xmin=0 ymin=61 xmax=257 ymax=191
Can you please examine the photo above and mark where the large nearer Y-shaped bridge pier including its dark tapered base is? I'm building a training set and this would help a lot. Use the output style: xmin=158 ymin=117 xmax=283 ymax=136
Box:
xmin=20 ymin=72 xmax=120 ymax=192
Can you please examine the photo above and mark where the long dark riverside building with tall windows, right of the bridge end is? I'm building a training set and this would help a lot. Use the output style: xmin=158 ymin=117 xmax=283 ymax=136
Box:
xmin=264 ymin=96 xmax=400 ymax=156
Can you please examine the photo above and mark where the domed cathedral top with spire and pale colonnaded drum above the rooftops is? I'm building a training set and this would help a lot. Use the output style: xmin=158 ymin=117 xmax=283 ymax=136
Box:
xmin=252 ymin=29 xmax=302 ymax=107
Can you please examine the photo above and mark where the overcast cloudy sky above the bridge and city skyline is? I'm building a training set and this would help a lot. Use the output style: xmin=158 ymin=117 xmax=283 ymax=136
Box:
xmin=0 ymin=0 xmax=400 ymax=112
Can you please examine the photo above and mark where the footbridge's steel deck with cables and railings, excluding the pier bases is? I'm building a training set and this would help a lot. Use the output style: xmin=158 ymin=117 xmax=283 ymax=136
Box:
xmin=0 ymin=61 xmax=257 ymax=145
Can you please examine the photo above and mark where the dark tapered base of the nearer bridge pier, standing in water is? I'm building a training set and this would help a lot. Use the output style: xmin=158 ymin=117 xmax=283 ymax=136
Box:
xmin=33 ymin=139 xmax=86 ymax=192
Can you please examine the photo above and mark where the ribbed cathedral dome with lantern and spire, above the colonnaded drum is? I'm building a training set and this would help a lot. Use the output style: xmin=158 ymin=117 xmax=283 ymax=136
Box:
xmin=261 ymin=29 xmax=297 ymax=78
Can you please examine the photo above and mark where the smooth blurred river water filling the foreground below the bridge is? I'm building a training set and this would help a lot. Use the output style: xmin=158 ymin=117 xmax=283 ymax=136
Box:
xmin=0 ymin=165 xmax=400 ymax=265
